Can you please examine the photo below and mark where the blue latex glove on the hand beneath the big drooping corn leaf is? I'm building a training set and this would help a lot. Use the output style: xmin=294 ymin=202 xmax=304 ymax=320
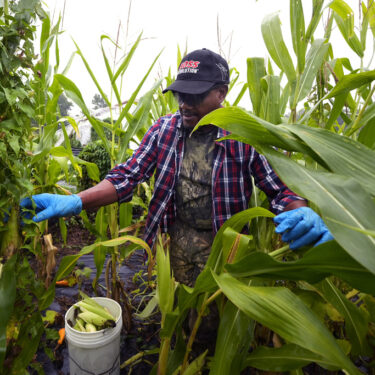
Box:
xmin=273 ymin=207 xmax=333 ymax=250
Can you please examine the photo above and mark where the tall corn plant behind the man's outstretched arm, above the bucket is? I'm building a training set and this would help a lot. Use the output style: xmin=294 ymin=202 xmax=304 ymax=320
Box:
xmin=51 ymin=27 xmax=166 ymax=329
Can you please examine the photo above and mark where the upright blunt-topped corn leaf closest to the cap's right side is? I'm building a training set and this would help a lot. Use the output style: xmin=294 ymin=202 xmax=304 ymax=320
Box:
xmin=247 ymin=57 xmax=267 ymax=116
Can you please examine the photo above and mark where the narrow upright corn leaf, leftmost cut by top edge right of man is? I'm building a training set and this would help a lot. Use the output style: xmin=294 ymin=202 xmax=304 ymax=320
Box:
xmin=290 ymin=0 xmax=307 ymax=73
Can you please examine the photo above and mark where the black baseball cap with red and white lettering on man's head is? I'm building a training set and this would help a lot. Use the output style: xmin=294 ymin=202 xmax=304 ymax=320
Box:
xmin=163 ymin=48 xmax=229 ymax=94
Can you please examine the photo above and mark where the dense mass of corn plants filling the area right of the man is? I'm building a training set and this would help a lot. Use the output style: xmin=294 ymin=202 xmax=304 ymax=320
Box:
xmin=138 ymin=0 xmax=375 ymax=374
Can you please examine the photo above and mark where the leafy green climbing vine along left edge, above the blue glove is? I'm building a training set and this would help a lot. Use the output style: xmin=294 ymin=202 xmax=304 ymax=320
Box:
xmin=0 ymin=0 xmax=43 ymax=217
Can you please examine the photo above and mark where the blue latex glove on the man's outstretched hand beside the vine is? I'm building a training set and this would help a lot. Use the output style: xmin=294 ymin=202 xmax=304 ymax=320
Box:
xmin=20 ymin=193 xmax=82 ymax=223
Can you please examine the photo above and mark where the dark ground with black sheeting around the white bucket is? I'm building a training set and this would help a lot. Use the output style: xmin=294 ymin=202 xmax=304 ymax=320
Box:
xmin=37 ymin=222 xmax=160 ymax=375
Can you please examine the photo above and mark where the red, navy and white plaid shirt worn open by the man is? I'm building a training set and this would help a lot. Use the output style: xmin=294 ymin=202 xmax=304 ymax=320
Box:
xmin=106 ymin=112 xmax=302 ymax=246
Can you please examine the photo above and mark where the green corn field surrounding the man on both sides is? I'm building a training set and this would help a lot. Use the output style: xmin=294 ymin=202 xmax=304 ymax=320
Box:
xmin=0 ymin=0 xmax=375 ymax=375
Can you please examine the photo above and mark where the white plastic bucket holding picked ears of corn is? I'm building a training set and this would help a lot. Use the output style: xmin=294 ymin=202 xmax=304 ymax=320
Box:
xmin=65 ymin=297 xmax=122 ymax=375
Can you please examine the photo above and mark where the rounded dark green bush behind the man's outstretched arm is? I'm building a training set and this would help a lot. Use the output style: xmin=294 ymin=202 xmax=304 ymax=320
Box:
xmin=78 ymin=141 xmax=111 ymax=190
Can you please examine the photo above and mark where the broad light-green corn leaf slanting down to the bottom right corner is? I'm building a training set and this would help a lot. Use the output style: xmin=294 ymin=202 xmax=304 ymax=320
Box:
xmin=214 ymin=274 xmax=360 ymax=375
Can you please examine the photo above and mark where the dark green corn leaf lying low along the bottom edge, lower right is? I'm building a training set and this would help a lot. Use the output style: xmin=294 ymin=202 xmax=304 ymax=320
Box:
xmin=245 ymin=344 xmax=339 ymax=372
